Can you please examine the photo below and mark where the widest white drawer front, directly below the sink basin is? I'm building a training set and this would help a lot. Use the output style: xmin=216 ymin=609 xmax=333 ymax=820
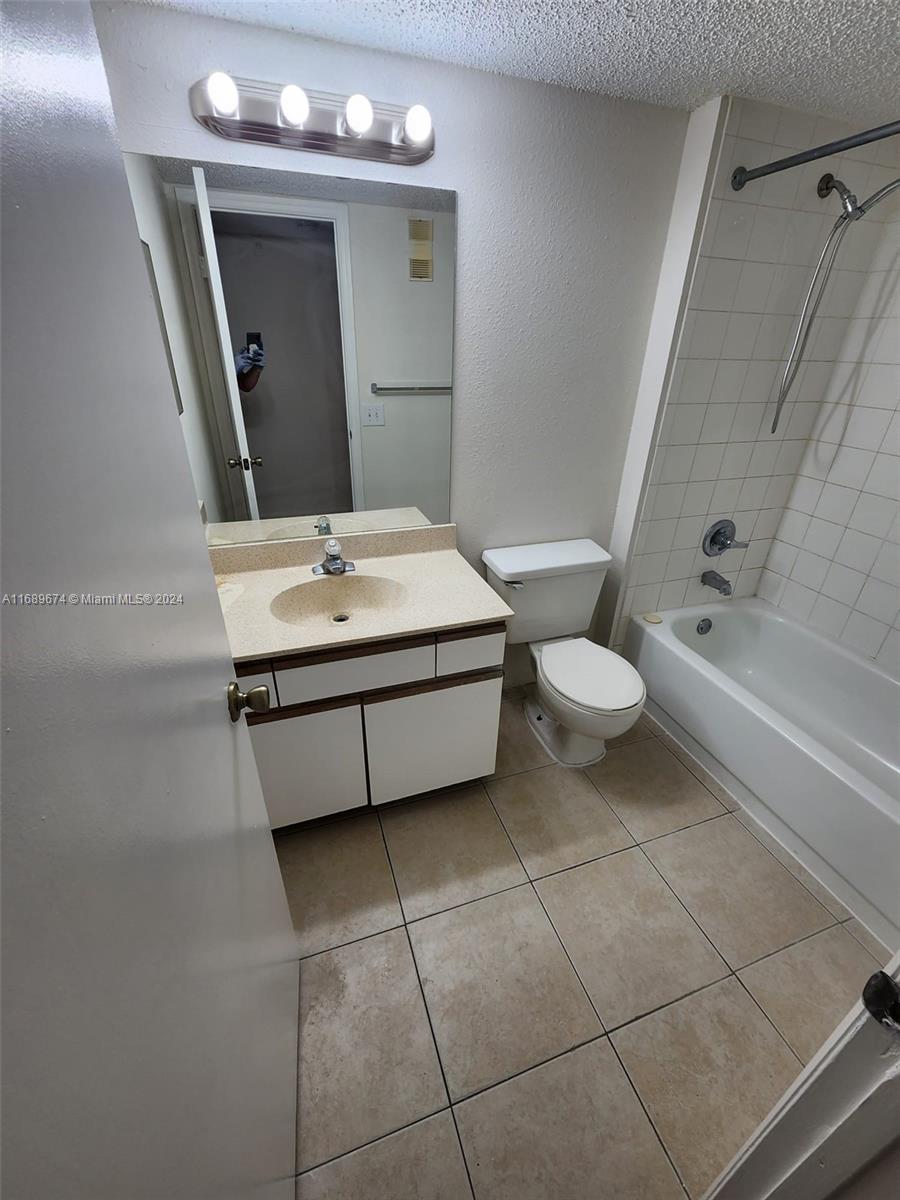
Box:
xmin=275 ymin=637 xmax=434 ymax=704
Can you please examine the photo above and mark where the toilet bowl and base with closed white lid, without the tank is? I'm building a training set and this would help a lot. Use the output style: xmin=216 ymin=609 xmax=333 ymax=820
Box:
xmin=524 ymin=637 xmax=647 ymax=767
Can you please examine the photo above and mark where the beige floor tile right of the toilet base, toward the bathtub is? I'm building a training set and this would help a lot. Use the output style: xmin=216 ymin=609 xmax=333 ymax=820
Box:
xmin=587 ymin=738 xmax=724 ymax=841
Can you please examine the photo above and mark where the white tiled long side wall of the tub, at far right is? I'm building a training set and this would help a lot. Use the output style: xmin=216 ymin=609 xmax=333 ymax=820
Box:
xmin=758 ymin=202 xmax=900 ymax=673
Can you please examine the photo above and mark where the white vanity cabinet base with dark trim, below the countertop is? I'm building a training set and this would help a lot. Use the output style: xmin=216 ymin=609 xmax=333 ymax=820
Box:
xmin=238 ymin=622 xmax=506 ymax=829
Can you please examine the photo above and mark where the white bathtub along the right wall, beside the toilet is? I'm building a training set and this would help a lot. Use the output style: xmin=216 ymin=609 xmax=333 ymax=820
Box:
xmin=625 ymin=599 xmax=900 ymax=948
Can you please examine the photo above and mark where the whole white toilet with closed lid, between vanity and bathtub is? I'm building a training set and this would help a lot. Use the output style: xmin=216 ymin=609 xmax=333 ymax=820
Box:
xmin=481 ymin=538 xmax=647 ymax=767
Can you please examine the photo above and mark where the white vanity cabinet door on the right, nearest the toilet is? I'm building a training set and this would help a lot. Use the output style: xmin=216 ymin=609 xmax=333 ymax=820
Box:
xmin=364 ymin=671 xmax=503 ymax=804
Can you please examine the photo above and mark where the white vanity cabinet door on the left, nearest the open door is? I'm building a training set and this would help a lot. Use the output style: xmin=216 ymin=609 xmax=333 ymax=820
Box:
xmin=247 ymin=701 xmax=368 ymax=829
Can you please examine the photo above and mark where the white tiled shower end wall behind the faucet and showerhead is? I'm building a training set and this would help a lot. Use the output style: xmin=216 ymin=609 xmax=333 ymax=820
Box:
xmin=613 ymin=101 xmax=896 ymax=644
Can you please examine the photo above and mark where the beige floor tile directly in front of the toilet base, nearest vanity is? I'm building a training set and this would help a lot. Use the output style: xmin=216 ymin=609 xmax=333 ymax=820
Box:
xmin=487 ymin=763 xmax=634 ymax=878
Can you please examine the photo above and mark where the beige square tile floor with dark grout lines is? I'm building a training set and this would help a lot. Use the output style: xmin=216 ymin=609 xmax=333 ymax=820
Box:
xmin=283 ymin=694 xmax=887 ymax=1200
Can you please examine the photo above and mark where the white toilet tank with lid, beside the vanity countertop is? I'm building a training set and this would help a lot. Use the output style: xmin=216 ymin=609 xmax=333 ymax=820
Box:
xmin=481 ymin=538 xmax=612 ymax=642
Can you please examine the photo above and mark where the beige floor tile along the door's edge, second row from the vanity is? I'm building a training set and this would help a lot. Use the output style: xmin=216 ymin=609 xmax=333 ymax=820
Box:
xmin=298 ymin=929 xmax=446 ymax=1171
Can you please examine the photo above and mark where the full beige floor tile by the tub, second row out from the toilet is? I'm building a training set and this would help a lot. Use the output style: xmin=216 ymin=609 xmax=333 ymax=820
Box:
xmin=644 ymin=816 xmax=834 ymax=968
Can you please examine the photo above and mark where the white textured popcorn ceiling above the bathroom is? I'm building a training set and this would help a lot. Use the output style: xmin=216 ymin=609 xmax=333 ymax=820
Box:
xmin=144 ymin=0 xmax=900 ymax=121
